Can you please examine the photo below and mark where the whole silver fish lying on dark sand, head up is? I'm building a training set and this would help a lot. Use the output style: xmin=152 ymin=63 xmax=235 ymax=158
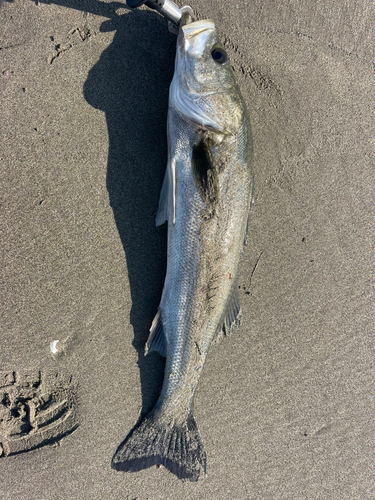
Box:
xmin=112 ymin=19 xmax=253 ymax=481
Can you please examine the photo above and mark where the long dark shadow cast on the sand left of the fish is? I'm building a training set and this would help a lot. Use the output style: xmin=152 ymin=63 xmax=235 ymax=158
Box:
xmin=84 ymin=11 xmax=176 ymax=423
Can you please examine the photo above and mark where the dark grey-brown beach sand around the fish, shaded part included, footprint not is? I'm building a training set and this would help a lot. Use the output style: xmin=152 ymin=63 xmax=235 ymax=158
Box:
xmin=0 ymin=0 xmax=375 ymax=500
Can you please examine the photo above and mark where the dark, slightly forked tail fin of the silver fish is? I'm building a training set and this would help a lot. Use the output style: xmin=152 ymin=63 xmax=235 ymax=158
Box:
xmin=112 ymin=411 xmax=206 ymax=481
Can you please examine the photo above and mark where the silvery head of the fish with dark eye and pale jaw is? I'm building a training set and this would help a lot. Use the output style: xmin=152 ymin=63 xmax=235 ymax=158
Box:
xmin=170 ymin=19 xmax=245 ymax=134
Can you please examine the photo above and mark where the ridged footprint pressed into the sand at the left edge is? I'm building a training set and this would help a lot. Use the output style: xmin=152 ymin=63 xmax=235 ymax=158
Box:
xmin=0 ymin=371 xmax=78 ymax=457
